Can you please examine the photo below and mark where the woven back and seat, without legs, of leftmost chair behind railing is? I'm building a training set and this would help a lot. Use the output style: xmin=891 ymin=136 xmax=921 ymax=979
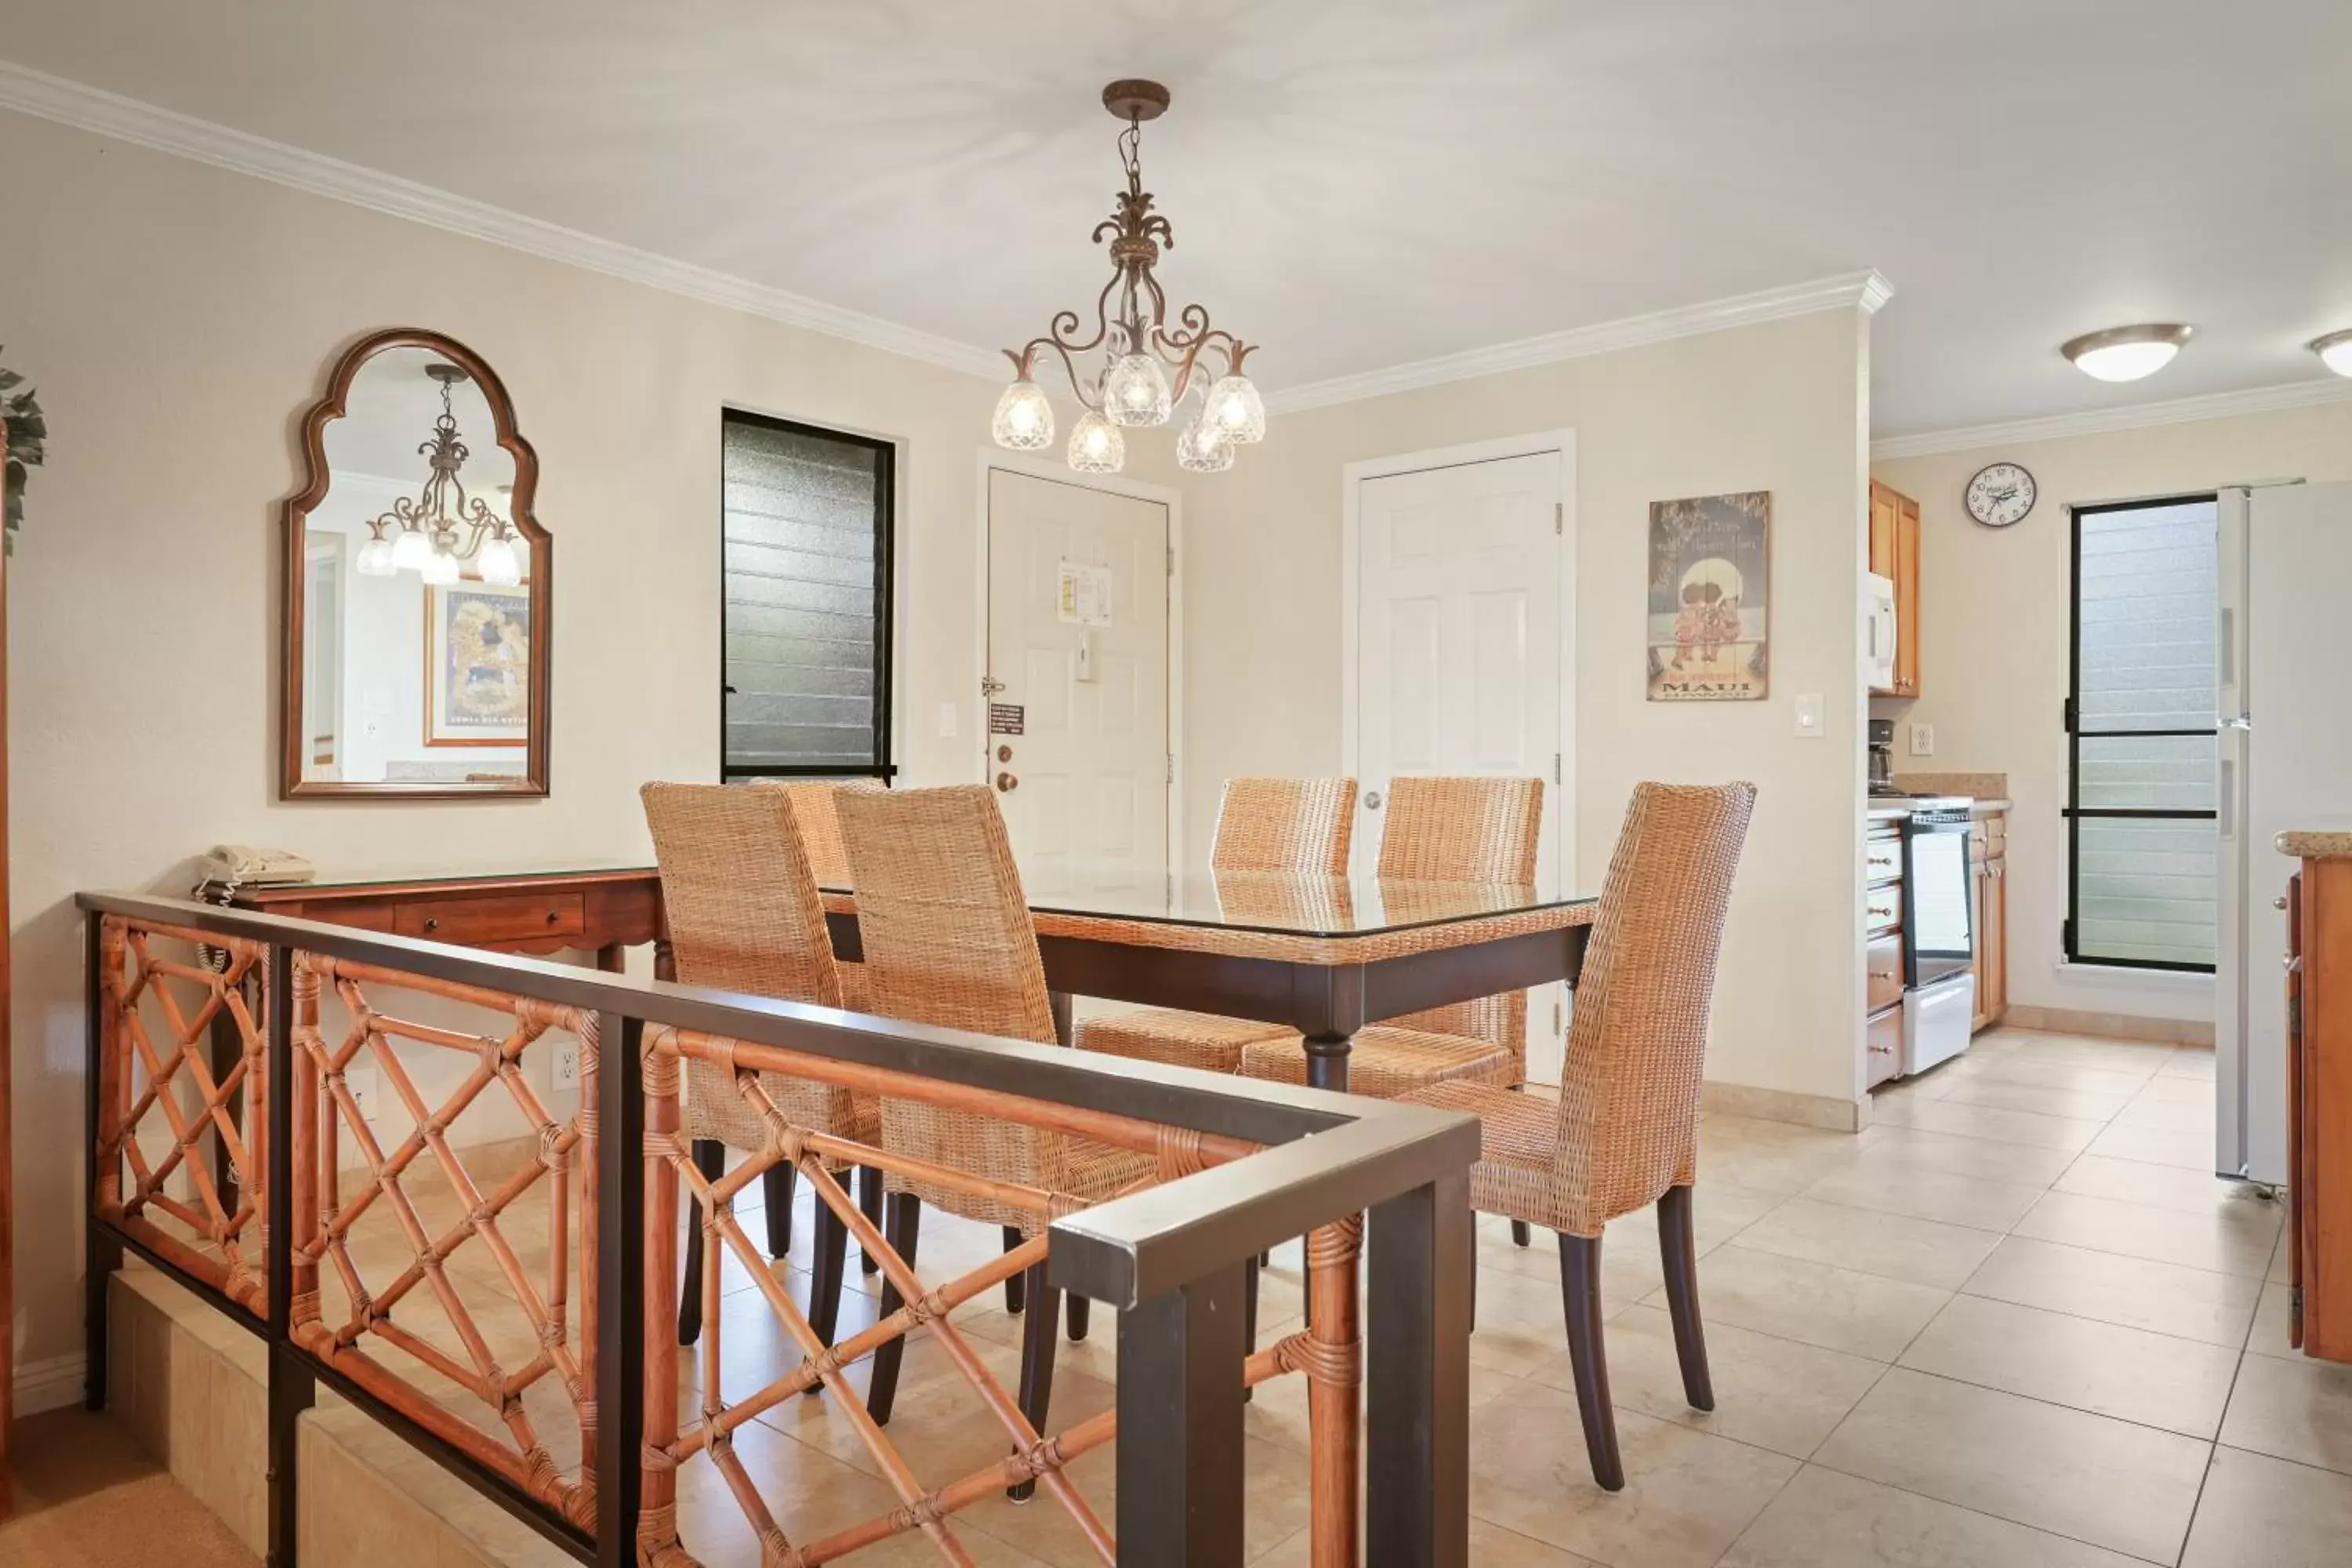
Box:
xmin=637 ymin=783 xmax=854 ymax=1149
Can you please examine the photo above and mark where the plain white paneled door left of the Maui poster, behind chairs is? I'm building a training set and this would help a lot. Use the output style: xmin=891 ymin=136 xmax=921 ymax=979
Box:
xmin=1355 ymin=452 xmax=1573 ymax=1081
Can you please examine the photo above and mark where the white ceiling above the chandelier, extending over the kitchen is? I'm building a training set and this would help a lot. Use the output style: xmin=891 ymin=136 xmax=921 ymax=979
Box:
xmin=0 ymin=0 xmax=2352 ymax=437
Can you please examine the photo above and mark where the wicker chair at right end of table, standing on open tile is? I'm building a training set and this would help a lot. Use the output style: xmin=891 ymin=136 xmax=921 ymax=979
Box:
xmin=1404 ymin=783 xmax=1757 ymax=1490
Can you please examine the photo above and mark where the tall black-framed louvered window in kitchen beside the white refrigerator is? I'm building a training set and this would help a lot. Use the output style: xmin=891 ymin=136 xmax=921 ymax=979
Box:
xmin=2067 ymin=496 xmax=2220 ymax=968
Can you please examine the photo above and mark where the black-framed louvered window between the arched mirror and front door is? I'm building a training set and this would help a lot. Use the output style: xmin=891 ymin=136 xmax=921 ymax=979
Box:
xmin=720 ymin=409 xmax=891 ymax=779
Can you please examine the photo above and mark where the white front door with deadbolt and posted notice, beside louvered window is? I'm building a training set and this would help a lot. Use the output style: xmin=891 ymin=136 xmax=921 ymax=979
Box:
xmin=985 ymin=468 xmax=1169 ymax=898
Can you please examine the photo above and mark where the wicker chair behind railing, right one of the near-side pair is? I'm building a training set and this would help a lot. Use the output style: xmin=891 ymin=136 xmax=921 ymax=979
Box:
xmin=835 ymin=785 xmax=1155 ymax=1497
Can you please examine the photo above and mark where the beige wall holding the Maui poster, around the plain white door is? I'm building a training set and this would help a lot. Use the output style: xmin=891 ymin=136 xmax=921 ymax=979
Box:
xmin=1185 ymin=310 xmax=1867 ymax=1102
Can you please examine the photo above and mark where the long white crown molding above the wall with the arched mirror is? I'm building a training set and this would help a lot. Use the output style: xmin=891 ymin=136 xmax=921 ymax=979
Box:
xmin=0 ymin=61 xmax=1004 ymax=381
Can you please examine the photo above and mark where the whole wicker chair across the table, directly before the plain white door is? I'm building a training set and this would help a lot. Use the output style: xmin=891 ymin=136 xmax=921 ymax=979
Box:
xmin=1240 ymin=776 xmax=1543 ymax=1100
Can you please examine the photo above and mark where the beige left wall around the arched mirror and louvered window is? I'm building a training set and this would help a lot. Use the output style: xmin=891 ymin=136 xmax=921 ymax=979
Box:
xmin=0 ymin=113 xmax=1049 ymax=1363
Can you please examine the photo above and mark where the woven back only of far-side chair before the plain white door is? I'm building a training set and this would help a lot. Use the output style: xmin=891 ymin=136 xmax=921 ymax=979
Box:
xmin=1381 ymin=776 xmax=1543 ymax=1076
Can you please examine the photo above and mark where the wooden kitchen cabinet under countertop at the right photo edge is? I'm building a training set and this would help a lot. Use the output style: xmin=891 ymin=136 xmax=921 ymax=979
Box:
xmin=2284 ymin=860 xmax=2352 ymax=1361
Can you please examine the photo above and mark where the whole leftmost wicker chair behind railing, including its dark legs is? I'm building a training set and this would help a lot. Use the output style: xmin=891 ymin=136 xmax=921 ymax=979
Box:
xmin=637 ymin=783 xmax=882 ymax=1345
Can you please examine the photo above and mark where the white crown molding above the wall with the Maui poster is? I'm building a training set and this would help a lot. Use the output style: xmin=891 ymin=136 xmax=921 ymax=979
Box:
xmin=1265 ymin=270 xmax=1896 ymax=414
